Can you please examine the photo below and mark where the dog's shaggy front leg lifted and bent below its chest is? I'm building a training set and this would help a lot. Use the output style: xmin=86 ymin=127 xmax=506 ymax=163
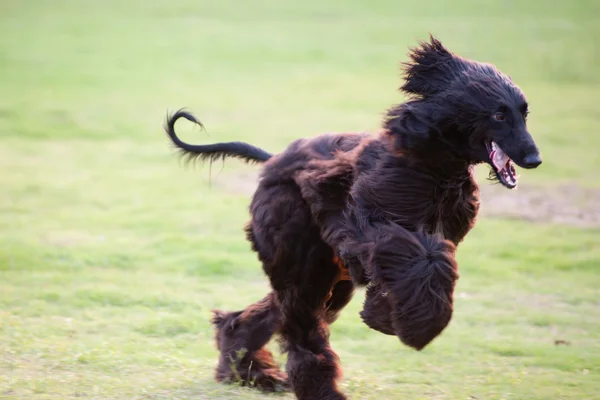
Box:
xmin=343 ymin=223 xmax=458 ymax=350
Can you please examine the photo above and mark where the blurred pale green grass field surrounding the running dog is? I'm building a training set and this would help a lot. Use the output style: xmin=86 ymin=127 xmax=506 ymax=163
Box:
xmin=0 ymin=0 xmax=600 ymax=400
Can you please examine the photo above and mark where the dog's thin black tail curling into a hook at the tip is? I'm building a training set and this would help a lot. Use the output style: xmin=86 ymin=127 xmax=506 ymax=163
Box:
xmin=165 ymin=110 xmax=273 ymax=163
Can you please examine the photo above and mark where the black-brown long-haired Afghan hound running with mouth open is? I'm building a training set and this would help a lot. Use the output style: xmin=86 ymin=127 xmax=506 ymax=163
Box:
xmin=165 ymin=36 xmax=542 ymax=400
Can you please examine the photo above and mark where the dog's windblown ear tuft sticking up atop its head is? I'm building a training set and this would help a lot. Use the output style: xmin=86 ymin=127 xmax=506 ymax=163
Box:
xmin=400 ymin=35 xmax=466 ymax=97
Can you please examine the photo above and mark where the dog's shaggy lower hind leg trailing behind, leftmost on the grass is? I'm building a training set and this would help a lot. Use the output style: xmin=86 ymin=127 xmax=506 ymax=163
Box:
xmin=213 ymin=293 xmax=288 ymax=391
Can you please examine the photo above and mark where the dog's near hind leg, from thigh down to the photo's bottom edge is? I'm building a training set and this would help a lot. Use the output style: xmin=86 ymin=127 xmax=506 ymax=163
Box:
xmin=248 ymin=182 xmax=348 ymax=400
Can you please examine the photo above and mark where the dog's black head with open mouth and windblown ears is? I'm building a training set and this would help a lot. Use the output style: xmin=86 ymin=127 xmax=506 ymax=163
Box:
xmin=392 ymin=37 xmax=542 ymax=189
